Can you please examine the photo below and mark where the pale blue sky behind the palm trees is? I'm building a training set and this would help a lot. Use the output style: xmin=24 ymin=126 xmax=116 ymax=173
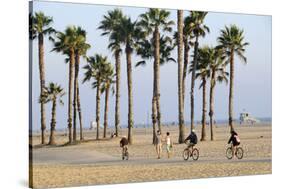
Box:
xmin=32 ymin=1 xmax=272 ymax=130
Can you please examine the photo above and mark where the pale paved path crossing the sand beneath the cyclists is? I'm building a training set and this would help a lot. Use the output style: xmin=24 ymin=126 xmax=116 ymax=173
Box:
xmin=33 ymin=148 xmax=271 ymax=166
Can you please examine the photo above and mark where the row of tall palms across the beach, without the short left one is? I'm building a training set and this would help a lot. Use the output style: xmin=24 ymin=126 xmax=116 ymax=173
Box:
xmin=30 ymin=9 xmax=248 ymax=144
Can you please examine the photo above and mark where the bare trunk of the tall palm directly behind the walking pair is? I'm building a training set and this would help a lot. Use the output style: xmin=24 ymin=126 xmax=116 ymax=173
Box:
xmin=153 ymin=27 xmax=161 ymax=132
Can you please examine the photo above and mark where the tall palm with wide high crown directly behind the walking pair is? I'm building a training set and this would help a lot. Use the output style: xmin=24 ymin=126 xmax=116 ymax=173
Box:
xmin=138 ymin=8 xmax=174 ymax=135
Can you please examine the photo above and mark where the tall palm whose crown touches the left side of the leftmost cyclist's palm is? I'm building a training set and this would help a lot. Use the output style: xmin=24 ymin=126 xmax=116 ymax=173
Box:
xmin=98 ymin=9 xmax=124 ymax=136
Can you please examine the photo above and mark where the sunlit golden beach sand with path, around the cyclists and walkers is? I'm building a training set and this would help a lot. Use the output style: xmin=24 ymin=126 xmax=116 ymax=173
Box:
xmin=29 ymin=124 xmax=272 ymax=188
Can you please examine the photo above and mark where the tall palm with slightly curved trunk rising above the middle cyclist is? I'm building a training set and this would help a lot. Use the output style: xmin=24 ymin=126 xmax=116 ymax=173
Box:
xmin=189 ymin=11 xmax=209 ymax=130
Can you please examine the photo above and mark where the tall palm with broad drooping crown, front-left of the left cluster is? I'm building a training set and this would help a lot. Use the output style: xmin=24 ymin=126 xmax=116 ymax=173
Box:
xmin=53 ymin=26 xmax=79 ymax=143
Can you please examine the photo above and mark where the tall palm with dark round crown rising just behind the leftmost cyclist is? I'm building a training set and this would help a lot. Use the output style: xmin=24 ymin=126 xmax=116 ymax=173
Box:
xmin=116 ymin=17 xmax=143 ymax=144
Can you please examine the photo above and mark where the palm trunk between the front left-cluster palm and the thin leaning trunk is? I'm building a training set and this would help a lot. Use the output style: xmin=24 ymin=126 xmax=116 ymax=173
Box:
xmin=73 ymin=52 xmax=79 ymax=142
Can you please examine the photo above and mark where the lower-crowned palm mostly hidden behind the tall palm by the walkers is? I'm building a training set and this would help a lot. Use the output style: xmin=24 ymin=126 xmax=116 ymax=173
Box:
xmin=136 ymin=35 xmax=176 ymax=144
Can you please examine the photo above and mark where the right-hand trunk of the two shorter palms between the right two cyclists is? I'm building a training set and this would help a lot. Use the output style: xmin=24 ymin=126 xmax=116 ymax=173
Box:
xmin=209 ymin=69 xmax=216 ymax=140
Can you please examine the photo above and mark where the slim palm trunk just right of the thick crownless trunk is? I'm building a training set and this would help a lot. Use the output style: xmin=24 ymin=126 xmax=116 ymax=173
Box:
xmin=182 ymin=36 xmax=189 ymax=109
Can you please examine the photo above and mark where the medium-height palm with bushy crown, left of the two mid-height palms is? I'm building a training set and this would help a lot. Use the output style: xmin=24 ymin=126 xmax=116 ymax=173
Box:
xmin=83 ymin=54 xmax=110 ymax=140
